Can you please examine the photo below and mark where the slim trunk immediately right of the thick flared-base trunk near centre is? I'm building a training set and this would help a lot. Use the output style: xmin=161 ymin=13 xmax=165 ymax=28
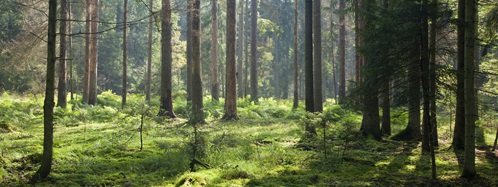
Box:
xmin=236 ymin=0 xmax=245 ymax=98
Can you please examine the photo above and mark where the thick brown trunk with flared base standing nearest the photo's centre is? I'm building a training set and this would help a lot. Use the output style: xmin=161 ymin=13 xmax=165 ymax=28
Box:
xmin=223 ymin=0 xmax=239 ymax=120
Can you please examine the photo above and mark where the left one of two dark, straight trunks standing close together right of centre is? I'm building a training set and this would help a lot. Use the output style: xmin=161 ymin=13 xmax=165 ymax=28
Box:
xmin=304 ymin=0 xmax=315 ymax=112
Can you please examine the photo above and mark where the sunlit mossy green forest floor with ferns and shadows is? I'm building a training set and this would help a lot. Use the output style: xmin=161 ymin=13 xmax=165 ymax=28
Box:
xmin=0 ymin=94 xmax=498 ymax=186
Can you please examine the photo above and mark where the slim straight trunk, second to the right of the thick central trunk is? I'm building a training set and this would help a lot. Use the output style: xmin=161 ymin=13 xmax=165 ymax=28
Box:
xmin=251 ymin=0 xmax=258 ymax=102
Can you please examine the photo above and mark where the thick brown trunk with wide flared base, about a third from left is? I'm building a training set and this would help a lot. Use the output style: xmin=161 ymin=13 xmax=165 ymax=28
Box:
xmin=158 ymin=0 xmax=176 ymax=118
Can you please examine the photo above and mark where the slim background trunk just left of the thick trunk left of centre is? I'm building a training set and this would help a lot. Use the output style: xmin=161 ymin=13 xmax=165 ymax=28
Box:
xmin=187 ymin=0 xmax=194 ymax=104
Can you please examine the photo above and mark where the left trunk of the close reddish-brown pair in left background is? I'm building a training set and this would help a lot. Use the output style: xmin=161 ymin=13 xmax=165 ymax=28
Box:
xmin=82 ymin=0 xmax=92 ymax=103
